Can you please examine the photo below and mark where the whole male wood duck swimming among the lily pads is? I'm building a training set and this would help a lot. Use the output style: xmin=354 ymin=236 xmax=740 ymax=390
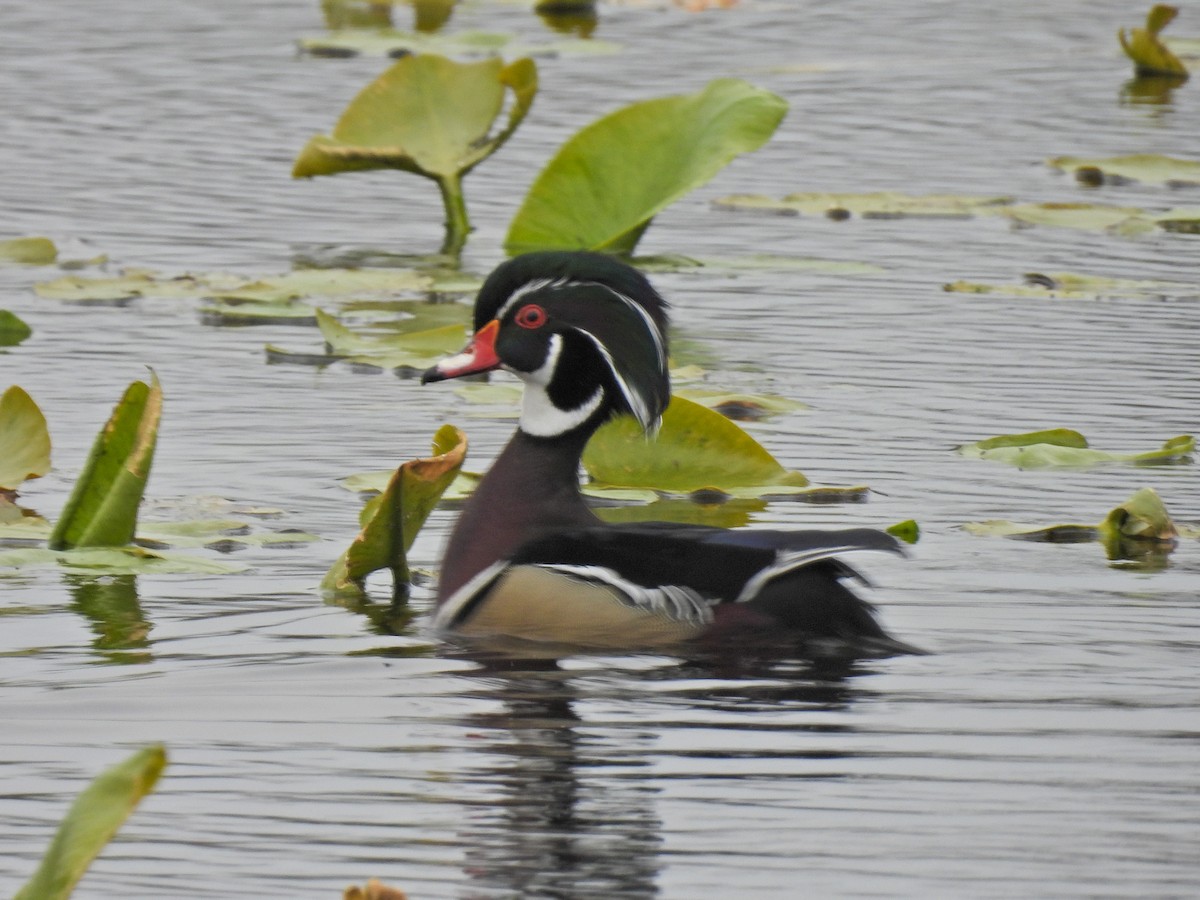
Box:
xmin=421 ymin=252 xmax=910 ymax=654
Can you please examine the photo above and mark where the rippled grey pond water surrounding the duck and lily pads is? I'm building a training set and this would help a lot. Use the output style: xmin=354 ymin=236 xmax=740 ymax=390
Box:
xmin=0 ymin=0 xmax=1200 ymax=898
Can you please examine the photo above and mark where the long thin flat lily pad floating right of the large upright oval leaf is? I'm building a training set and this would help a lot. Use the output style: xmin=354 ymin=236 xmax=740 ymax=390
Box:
xmin=714 ymin=191 xmax=1013 ymax=220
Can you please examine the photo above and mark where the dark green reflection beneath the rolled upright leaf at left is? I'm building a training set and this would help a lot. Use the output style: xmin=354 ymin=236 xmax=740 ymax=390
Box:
xmin=64 ymin=575 xmax=154 ymax=664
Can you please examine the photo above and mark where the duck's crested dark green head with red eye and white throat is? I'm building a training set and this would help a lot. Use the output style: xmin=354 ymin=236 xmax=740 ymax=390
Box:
xmin=421 ymin=251 xmax=671 ymax=437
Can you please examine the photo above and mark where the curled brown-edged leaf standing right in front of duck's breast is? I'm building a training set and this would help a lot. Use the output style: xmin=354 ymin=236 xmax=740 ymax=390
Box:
xmin=322 ymin=425 xmax=467 ymax=599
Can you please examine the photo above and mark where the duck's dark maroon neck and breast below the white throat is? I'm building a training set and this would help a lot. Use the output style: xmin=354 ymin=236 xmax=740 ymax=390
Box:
xmin=438 ymin=425 xmax=599 ymax=602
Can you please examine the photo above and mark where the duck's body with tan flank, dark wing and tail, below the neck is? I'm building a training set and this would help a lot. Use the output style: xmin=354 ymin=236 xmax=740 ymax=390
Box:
xmin=434 ymin=522 xmax=899 ymax=648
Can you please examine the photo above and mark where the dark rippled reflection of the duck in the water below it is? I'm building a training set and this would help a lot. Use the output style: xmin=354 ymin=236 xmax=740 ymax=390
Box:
xmin=451 ymin=653 xmax=865 ymax=900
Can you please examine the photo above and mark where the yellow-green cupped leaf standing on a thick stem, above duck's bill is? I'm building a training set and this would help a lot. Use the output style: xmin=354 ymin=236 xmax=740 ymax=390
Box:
xmin=292 ymin=54 xmax=538 ymax=256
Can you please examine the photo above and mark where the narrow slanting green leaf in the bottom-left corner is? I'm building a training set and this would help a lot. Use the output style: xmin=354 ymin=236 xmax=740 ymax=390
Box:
xmin=14 ymin=744 xmax=167 ymax=900
